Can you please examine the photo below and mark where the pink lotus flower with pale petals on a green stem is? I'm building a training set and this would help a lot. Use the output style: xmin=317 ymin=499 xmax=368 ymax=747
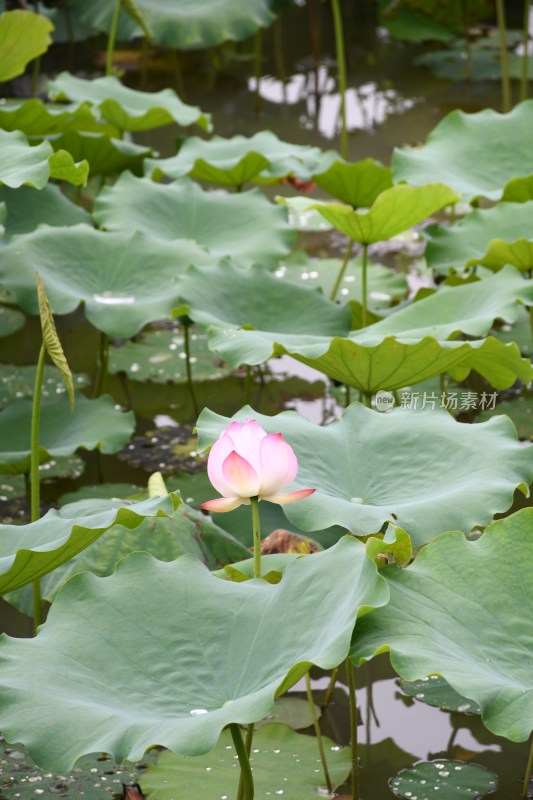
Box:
xmin=202 ymin=419 xmax=315 ymax=511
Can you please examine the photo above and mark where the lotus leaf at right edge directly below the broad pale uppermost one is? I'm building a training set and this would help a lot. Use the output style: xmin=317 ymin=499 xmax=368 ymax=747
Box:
xmin=424 ymin=201 xmax=533 ymax=272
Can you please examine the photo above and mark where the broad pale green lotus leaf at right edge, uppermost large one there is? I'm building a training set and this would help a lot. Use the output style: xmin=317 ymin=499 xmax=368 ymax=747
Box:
xmin=392 ymin=100 xmax=533 ymax=200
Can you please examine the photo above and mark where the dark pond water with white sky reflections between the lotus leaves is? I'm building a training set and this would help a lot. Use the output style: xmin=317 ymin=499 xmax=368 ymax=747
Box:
xmin=0 ymin=3 xmax=533 ymax=800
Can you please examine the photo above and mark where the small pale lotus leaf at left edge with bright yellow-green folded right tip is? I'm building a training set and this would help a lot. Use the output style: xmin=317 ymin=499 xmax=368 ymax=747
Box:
xmin=0 ymin=130 xmax=87 ymax=189
